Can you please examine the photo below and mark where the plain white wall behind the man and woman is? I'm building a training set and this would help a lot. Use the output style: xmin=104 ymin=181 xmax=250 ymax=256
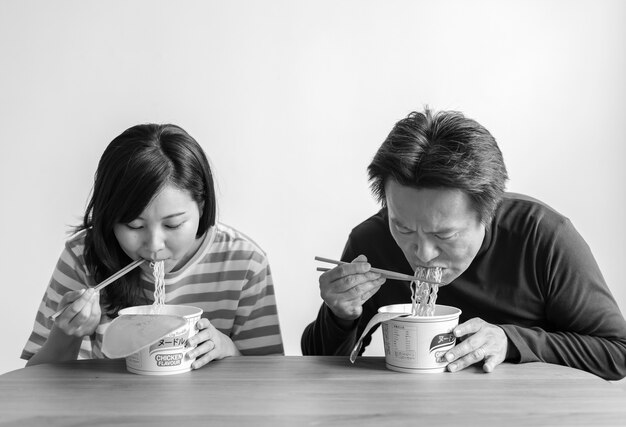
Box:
xmin=0 ymin=0 xmax=626 ymax=373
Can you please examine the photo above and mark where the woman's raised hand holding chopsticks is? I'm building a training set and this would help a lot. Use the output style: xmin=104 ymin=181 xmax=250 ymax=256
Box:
xmin=54 ymin=288 xmax=101 ymax=338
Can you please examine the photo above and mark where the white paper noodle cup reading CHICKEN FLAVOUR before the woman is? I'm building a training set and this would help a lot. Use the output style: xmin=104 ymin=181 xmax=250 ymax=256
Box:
xmin=119 ymin=304 xmax=202 ymax=375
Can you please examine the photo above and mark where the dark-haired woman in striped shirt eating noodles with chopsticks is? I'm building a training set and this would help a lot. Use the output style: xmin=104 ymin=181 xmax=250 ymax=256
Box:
xmin=22 ymin=124 xmax=284 ymax=369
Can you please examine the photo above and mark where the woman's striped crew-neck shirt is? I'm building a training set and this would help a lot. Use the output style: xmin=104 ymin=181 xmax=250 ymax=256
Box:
xmin=21 ymin=223 xmax=284 ymax=359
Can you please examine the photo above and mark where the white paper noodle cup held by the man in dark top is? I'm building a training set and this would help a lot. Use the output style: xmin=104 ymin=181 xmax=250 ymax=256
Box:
xmin=378 ymin=304 xmax=461 ymax=373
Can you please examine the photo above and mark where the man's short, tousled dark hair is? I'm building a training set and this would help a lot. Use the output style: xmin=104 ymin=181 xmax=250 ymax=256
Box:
xmin=367 ymin=108 xmax=508 ymax=226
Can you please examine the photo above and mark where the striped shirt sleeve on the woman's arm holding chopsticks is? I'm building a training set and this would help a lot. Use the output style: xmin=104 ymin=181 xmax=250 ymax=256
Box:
xmin=21 ymin=243 xmax=92 ymax=360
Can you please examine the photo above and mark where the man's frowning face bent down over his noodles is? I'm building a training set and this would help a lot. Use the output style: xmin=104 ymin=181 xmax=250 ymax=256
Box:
xmin=385 ymin=179 xmax=485 ymax=284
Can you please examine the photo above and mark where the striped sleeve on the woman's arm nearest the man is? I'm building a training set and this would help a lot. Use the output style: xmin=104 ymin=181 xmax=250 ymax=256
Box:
xmin=230 ymin=253 xmax=285 ymax=355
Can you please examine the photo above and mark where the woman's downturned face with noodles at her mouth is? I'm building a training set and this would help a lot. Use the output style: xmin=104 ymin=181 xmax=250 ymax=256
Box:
xmin=113 ymin=184 xmax=201 ymax=272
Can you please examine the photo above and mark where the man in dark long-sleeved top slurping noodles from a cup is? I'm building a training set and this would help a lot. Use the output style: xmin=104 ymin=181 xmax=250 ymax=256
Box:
xmin=301 ymin=109 xmax=626 ymax=380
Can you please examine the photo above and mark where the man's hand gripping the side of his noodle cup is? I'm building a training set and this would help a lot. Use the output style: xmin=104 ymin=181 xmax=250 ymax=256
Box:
xmin=444 ymin=317 xmax=508 ymax=372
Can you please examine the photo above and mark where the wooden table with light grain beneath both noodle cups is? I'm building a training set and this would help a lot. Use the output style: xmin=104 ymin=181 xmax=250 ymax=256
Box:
xmin=0 ymin=356 xmax=626 ymax=427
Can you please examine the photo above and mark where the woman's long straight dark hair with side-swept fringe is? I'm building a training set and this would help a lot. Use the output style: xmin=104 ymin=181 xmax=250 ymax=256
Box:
xmin=77 ymin=124 xmax=217 ymax=316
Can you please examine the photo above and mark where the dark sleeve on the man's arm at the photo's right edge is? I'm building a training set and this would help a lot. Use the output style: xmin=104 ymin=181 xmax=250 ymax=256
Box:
xmin=500 ymin=221 xmax=626 ymax=380
